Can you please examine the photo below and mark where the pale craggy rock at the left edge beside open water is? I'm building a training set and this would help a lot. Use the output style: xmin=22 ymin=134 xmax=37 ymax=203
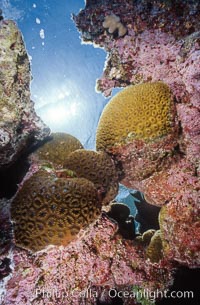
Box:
xmin=0 ymin=20 xmax=49 ymax=168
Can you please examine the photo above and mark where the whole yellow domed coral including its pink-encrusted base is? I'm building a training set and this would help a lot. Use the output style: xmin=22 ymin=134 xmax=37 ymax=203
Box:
xmin=96 ymin=82 xmax=178 ymax=184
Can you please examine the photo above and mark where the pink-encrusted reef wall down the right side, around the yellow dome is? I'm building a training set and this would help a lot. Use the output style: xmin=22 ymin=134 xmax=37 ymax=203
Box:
xmin=74 ymin=0 xmax=200 ymax=267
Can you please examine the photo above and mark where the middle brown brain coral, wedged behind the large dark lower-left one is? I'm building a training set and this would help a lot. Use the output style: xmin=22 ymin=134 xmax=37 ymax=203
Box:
xmin=64 ymin=149 xmax=118 ymax=204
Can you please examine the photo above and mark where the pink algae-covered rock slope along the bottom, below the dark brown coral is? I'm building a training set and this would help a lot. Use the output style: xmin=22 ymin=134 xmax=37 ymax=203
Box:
xmin=2 ymin=215 xmax=173 ymax=305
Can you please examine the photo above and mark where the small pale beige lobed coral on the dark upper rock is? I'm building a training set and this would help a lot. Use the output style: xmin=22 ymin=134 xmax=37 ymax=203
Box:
xmin=103 ymin=14 xmax=127 ymax=37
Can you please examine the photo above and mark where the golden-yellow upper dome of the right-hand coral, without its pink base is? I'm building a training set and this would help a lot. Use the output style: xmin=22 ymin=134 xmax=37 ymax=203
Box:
xmin=96 ymin=82 xmax=174 ymax=152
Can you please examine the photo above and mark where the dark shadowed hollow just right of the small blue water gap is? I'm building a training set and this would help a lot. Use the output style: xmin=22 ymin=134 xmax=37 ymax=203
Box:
xmin=130 ymin=191 xmax=160 ymax=233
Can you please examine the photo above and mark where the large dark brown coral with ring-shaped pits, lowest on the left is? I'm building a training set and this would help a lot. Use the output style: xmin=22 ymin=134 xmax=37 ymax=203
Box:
xmin=11 ymin=170 xmax=100 ymax=251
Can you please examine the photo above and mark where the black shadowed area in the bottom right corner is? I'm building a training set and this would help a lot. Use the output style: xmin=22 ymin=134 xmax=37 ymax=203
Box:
xmin=156 ymin=267 xmax=200 ymax=305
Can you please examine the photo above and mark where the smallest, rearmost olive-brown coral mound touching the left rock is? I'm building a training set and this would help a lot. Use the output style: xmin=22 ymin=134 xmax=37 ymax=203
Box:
xmin=34 ymin=132 xmax=83 ymax=167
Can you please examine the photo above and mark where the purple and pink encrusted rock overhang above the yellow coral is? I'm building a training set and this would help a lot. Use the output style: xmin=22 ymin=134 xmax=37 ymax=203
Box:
xmin=74 ymin=0 xmax=200 ymax=98
